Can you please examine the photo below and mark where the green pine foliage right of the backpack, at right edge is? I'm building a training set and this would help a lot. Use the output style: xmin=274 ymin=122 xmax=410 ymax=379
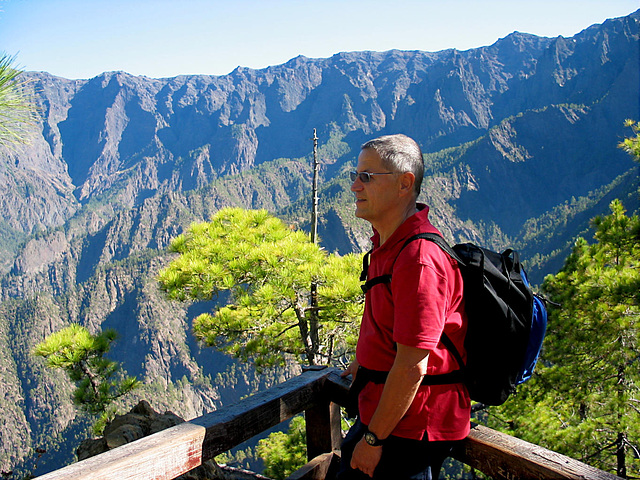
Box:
xmin=490 ymin=200 xmax=640 ymax=478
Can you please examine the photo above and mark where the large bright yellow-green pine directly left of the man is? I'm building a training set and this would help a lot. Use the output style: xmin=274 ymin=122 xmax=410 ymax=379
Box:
xmin=159 ymin=208 xmax=362 ymax=368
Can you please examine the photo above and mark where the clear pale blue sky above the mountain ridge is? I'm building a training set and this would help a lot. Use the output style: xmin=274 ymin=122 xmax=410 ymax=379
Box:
xmin=0 ymin=0 xmax=640 ymax=78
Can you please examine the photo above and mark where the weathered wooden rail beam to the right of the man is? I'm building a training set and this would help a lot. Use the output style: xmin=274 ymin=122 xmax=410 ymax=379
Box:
xmin=453 ymin=425 xmax=620 ymax=480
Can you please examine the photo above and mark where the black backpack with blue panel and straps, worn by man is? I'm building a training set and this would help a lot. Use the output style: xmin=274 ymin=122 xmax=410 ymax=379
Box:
xmin=360 ymin=233 xmax=547 ymax=405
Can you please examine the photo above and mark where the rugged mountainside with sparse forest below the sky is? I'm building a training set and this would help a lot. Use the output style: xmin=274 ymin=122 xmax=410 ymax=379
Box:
xmin=0 ymin=12 xmax=640 ymax=472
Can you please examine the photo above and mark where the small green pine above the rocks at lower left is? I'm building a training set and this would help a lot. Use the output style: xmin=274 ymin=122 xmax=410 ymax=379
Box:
xmin=34 ymin=324 xmax=139 ymax=415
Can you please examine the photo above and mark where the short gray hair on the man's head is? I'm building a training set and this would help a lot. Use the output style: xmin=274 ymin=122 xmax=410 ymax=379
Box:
xmin=361 ymin=133 xmax=424 ymax=198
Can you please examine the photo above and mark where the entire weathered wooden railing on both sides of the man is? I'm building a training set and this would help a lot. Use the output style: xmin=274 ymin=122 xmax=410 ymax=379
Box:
xmin=37 ymin=368 xmax=619 ymax=480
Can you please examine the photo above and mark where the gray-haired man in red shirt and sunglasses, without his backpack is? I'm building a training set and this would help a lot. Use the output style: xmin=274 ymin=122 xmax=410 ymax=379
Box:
xmin=338 ymin=135 xmax=471 ymax=480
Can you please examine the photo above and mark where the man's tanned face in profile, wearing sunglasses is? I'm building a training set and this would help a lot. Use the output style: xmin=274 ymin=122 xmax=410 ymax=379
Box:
xmin=351 ymin=148 xmax=398 ymax=230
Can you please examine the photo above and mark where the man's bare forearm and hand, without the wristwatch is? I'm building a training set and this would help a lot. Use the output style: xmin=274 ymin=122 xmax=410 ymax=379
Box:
xmin=351 ymin=344 xmax=430 ymax=477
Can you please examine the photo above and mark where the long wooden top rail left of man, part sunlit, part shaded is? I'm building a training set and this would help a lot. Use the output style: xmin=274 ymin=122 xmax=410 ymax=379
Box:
xmin=32 ymin=369 xmax=332 ymax=480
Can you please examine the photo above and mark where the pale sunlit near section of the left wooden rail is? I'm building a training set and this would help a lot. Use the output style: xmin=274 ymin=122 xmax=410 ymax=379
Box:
xmin=33 ymin=422 xmax=206 ymax=480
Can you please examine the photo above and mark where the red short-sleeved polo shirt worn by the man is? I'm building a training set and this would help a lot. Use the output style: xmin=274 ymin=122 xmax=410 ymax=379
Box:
xmin=356 ymin=204 xmax=471 ymax=441
